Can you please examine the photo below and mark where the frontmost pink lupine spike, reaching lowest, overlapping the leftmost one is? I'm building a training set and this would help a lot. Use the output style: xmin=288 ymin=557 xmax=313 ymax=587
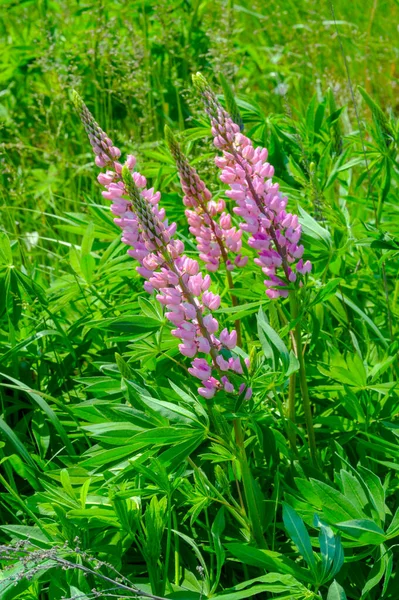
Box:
xmin=122 ymin=166 xmax=248 ymax=399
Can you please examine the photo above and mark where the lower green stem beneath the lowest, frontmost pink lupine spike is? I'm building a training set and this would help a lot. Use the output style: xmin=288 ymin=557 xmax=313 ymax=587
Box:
xmin=233 ymin=419 xmax=267 ymax=548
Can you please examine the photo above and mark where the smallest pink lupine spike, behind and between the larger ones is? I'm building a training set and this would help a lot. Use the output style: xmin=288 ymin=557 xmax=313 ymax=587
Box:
xmin=165 ymin=127 xmax=248 ymax=272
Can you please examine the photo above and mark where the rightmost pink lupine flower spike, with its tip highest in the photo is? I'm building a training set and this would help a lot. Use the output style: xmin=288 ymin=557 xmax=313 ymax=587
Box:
xmin=194 ymin=73 xmax=312 ymax=298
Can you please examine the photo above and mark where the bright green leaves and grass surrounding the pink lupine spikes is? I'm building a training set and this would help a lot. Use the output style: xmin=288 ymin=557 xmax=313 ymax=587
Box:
xmin=0 ymin=0 xmax=399 ymax=600
